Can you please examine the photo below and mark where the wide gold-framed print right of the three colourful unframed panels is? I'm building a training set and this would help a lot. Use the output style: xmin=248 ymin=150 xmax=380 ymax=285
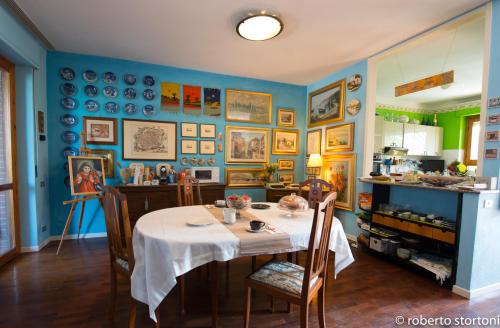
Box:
xmin=226 ymin=89 xmax=273 ymax=124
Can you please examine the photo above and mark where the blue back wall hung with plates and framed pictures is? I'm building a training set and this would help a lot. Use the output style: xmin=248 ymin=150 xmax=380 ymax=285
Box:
xmin=47 ymin=52 xmax=306 ymax=235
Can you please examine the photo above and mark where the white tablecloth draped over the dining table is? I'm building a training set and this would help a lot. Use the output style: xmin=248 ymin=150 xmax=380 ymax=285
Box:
xmin=132 ymin=203 xmax=354 ymax=320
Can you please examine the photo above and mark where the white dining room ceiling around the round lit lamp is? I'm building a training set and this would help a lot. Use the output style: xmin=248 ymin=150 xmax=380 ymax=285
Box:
xmin=16 ymin=0 xmax=487 ymax=85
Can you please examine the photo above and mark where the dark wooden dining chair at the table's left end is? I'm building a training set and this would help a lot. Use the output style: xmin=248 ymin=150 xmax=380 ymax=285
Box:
xmin=103 ymin=186 xmax=160 ymax=327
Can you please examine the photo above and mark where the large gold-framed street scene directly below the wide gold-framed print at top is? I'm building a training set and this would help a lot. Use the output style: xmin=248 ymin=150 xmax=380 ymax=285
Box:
xmin=226 ymin=126 xmax=269 ymax=164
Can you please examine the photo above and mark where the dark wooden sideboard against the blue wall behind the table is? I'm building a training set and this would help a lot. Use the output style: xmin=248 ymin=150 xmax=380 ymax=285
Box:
xmin=117 ymin=184 xmax=225 ymax=227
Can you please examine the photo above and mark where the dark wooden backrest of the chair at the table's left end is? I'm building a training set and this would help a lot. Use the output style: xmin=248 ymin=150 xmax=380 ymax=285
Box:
xmin=103 ymin=186 xmax=135 ymax=273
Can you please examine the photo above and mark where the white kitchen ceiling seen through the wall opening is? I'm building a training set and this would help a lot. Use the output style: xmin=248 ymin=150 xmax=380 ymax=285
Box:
xmin=377 ymin=13 xmax=485 ymax=109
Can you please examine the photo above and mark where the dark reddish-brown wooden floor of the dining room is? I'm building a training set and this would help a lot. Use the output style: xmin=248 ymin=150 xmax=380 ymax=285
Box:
xmin=0 ymin=238 xmax=500 ymax=328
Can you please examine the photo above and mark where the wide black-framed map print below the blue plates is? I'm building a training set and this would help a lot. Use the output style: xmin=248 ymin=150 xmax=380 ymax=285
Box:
xmin=122 ymin=119 xmax=177 ymax=161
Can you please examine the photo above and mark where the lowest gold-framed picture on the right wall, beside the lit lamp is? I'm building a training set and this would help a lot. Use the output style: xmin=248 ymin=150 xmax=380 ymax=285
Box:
xmin=321 ymin=154 xmax=356 ymax=211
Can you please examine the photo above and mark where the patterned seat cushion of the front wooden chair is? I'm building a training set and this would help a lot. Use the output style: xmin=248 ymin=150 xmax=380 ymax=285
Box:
xmin=250 ymin=261 xmax=317 ymax=295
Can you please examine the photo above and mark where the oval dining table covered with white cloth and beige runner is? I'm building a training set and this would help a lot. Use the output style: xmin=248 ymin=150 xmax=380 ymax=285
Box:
xmin=131 ymin=203 xmax=354 ymax=327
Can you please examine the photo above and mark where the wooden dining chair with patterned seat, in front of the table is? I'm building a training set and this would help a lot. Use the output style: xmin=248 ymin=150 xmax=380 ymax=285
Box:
xmin=243 ymin=192 xmax=337 ymax=328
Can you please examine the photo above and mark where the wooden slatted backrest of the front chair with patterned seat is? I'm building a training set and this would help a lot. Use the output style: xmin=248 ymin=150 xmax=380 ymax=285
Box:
xmin=302 ymin=192 xmax=337 ymax=295
